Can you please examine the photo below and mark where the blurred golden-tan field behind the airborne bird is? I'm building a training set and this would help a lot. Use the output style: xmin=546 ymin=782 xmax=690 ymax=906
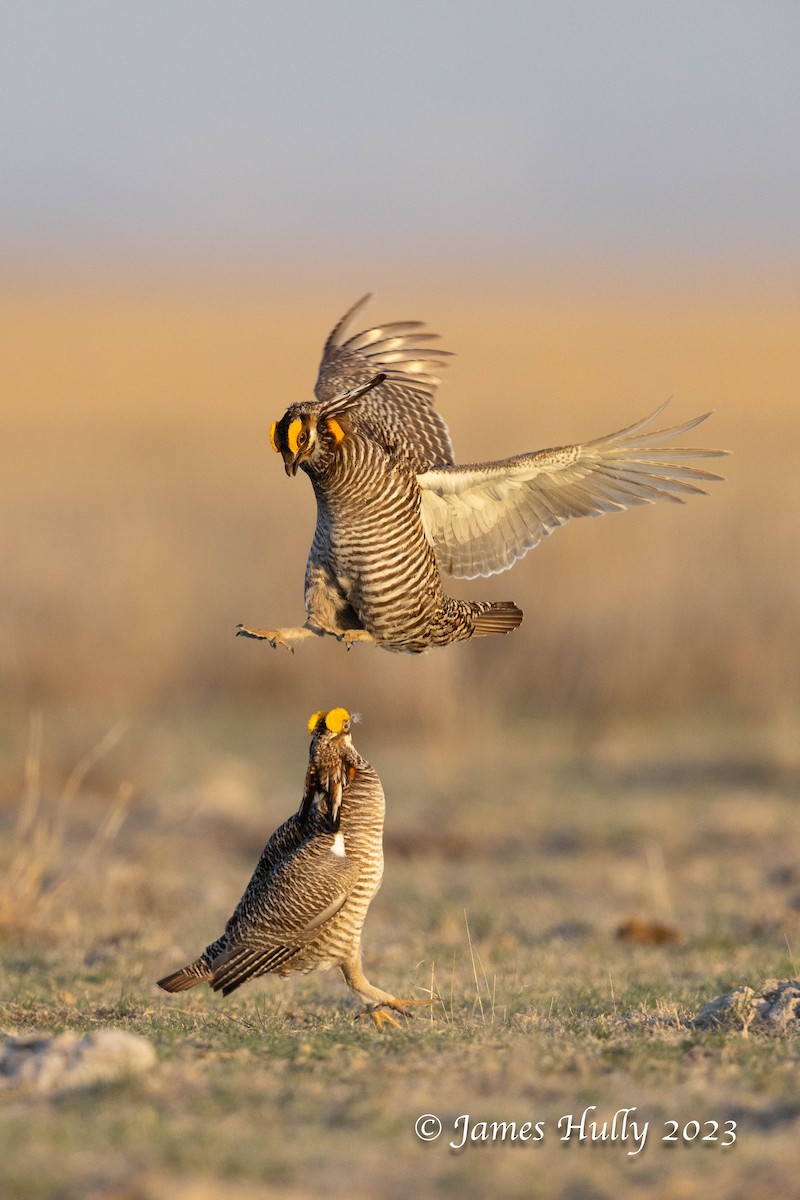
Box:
xmin=0 ymin=280 xmax=800 ymax=721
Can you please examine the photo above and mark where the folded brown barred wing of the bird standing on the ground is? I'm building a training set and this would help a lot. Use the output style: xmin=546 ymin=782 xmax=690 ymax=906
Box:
xmin=211 ymin=846 xmax=359 ymax=996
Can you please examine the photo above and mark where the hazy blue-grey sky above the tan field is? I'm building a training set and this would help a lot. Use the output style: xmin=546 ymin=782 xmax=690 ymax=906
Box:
xmin=0 ymin=0 xmax=800 ymax=269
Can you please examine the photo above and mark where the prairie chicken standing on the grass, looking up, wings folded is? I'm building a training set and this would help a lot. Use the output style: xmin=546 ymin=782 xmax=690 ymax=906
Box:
xmin=158 ymin=708 xmax=427 ymax=1027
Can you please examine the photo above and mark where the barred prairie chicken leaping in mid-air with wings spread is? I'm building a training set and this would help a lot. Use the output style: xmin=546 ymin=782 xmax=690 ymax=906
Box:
xmin=237 ymin=296 xmax=724 ymax=654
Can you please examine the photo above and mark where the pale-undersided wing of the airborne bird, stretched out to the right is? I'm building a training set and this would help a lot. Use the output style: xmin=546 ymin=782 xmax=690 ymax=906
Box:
xmin=417 ymin=402 xmax=727 ymax=580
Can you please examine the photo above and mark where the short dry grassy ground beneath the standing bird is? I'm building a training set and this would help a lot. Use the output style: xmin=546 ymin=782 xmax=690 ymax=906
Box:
xmin=0 ymin=702 xmax=800 ymax=1200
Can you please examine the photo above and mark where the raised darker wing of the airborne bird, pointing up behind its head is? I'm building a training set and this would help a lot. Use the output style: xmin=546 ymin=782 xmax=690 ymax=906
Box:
xmin=314 ymin=294 xmax=455 ymax=472
